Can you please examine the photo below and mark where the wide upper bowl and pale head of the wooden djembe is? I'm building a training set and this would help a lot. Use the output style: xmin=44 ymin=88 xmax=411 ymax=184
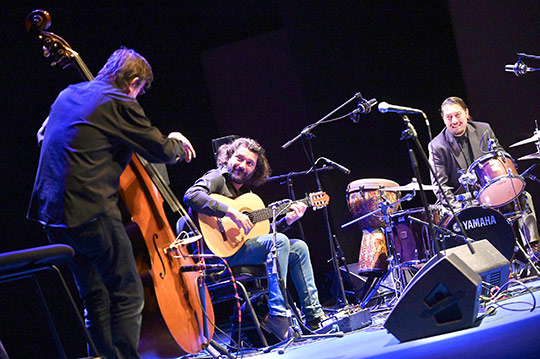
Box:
xmin=346 ymin=178 xmax=400 ymax=228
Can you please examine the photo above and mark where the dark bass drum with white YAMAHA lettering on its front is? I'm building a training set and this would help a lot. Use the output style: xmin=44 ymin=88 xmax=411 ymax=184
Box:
xmin=440 ymin=207 xmax=516 ymax=260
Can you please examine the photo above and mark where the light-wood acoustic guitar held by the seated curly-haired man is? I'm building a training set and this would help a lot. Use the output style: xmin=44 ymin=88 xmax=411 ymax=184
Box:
xmin=199 ymin=192 xmax=330 ymax=257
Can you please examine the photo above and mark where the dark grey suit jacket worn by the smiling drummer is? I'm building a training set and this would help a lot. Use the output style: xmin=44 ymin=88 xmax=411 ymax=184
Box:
xmin=428 ymin=121 xmax=504 ymax=208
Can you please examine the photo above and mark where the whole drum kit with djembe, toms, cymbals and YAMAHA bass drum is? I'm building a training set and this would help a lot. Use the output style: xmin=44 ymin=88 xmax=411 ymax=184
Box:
xmin=342 ymin=130 xmax=540 ymax=305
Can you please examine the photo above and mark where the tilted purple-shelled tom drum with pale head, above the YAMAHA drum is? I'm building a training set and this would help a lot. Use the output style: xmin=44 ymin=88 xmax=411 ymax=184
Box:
xmin=467 ymin=151 xmax=525 ymax=207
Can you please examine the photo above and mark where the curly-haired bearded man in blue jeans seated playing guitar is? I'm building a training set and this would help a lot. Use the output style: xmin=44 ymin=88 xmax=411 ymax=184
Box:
xmin=184 ymin=138 xmax=324 ymax=339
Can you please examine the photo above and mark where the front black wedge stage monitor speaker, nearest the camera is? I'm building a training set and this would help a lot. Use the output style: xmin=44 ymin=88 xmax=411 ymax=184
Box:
xmin=384 ymin=253 xmax=482 ymax=342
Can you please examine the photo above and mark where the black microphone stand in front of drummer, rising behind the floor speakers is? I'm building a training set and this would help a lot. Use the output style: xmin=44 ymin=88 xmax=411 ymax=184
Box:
xmin=400 ymin=115 xmax=475 ymax=258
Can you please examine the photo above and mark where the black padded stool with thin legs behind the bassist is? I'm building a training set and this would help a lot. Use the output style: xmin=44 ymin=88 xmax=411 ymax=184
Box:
xmin=0 ymin=244 xmax=103 ymax=359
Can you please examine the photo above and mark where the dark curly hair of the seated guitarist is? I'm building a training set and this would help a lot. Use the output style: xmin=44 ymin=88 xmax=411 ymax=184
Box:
xmin=216 ymin=137 xmax=272 ymax=187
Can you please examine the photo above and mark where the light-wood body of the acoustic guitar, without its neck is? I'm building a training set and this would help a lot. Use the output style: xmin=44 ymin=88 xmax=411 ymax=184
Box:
xmin=199 ymin=193 xmax=270 ymax=257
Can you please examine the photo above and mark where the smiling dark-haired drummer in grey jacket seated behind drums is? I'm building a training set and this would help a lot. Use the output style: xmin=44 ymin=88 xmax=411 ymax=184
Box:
xmin=429 ymin=97 xmax=540 ymax=250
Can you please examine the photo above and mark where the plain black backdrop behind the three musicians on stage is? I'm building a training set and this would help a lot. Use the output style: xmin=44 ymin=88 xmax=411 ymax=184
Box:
xmin=0 ymin=0 xmax=540 ymax=358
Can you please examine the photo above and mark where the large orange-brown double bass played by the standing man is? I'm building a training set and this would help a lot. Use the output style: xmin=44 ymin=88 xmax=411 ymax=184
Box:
xmin=25 ymin=10 xmax=214 ymax=353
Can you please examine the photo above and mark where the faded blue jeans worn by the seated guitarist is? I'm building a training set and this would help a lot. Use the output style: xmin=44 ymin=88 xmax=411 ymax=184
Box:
xmin=228 ymin=233 xmax=323 ymax=321
